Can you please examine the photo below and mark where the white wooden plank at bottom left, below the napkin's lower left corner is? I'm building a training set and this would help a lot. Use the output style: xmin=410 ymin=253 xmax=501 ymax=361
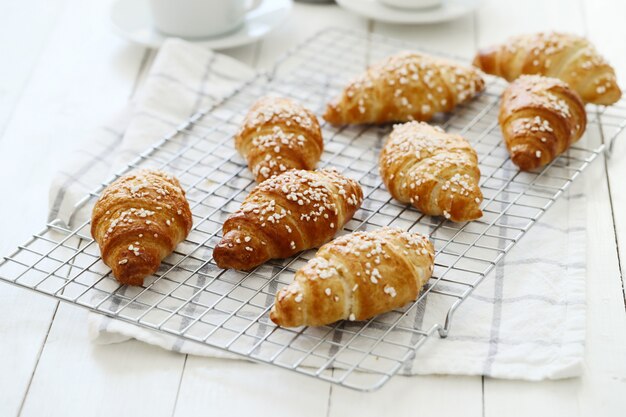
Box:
xmin=21 ymin=304 xmax=183 ymax=417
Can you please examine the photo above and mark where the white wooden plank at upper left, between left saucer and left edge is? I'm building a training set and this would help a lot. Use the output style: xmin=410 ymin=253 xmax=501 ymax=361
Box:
xmin=0 ymin=0 xmax=144 ymax=249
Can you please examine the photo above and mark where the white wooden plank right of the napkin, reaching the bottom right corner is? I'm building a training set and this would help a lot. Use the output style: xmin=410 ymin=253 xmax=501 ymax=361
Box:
xmin=578 ymin=154 xmax=626 ymax=416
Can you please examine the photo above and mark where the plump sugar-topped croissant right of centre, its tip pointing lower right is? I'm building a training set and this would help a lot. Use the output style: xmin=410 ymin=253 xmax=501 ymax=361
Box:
xmin=380 ymin=122 xmax=483 ymax=222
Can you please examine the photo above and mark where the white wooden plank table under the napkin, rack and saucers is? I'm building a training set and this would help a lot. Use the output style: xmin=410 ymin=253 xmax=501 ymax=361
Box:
xmin=0 ymin=0 xmax=626 ymax=417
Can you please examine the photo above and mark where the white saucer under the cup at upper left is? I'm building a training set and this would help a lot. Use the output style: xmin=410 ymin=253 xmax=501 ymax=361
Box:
xmin=111 ymin=0 xmax=291 ymax=49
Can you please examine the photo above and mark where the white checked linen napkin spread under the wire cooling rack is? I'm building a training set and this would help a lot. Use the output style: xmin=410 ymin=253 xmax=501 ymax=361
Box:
xmin=49 ymin=40 xmax=586 ymax=380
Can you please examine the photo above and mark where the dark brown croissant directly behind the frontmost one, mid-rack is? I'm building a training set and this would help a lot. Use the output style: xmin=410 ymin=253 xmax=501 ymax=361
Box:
xmin=213 ymin=170 xmax=363 ymax=270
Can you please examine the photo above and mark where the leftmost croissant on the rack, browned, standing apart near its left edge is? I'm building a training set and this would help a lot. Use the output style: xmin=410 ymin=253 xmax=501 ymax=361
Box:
xmin=91 ymin=169 xmax=192 ymax=285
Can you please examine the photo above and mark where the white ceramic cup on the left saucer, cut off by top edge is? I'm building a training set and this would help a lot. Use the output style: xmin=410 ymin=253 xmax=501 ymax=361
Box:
xmin=150 ymin=0 xmax=262 ymax=38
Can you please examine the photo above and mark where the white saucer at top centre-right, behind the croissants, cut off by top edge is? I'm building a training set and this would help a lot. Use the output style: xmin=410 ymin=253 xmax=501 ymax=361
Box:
xmin=336 ymin=0 xmax=480 ymax=24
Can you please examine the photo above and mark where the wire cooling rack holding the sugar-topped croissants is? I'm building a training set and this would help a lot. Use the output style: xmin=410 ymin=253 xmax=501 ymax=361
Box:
xmin=0 ymin=29 xmax=626 ymax=390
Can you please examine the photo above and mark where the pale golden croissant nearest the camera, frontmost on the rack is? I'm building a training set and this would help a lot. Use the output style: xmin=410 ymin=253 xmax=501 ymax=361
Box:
xmin=270 ymin=228 xmax=435 ymax=327
